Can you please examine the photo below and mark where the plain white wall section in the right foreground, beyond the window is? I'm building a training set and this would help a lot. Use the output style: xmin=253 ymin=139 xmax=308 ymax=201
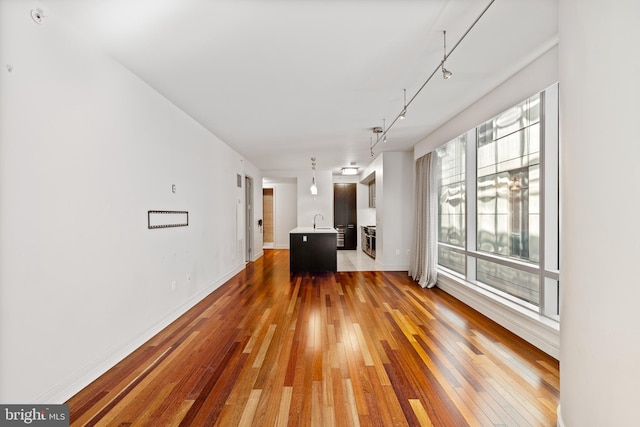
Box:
xmin=559 ymin=0 xmax=640 ymax=427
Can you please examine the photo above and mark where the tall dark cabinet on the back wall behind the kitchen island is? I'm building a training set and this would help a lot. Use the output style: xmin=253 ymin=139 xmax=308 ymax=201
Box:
xmin=333 ymin=183 xmax=358 ymax=250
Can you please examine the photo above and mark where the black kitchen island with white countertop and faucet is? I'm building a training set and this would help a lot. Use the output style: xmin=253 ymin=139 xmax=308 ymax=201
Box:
xmin=289 ymin=227 xmax=338 ymax=273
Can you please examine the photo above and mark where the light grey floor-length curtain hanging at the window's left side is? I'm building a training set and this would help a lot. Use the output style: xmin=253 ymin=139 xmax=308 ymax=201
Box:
xmin=409 ymin=152 xmax=438 ymax=288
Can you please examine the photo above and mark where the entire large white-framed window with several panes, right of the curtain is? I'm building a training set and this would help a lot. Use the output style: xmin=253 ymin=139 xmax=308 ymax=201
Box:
xmin=437 ymin=85 xmax=559 ymax=317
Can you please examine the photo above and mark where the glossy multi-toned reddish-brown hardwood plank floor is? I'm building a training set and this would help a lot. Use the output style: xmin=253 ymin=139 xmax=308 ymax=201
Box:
xmin=67 ymin=250 xmax=559 ymax=427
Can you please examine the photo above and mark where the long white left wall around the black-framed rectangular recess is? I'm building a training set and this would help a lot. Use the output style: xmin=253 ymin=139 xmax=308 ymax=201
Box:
xmin=0 ymin=1 xmax=260 ymax=403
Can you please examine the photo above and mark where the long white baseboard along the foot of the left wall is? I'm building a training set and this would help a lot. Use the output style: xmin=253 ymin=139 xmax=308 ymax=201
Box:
xmin=31 ymin=264 xmax=245 ymax=404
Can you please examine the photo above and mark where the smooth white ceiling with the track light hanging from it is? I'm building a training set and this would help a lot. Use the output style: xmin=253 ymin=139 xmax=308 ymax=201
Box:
xmin=43 ymin=0 xmax=558 ymax=173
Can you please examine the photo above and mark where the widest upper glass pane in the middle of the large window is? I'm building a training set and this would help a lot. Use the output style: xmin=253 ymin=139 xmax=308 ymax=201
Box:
xmin=477 ymin=95 xmax=540 ymax=262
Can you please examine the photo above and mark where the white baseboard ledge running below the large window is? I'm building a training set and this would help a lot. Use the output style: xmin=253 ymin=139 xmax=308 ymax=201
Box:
xmin=437 ymin=272 xmax=560 ymax=359
